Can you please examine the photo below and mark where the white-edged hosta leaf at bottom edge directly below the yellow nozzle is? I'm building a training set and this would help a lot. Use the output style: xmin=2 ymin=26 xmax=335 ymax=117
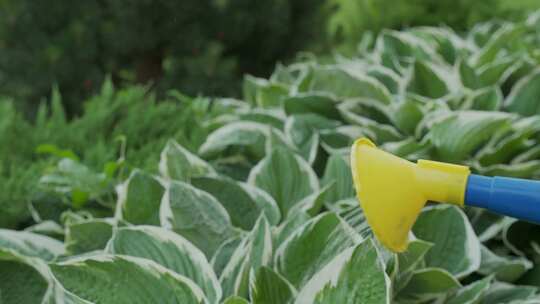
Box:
xmin=296 ymin=239 xmax=391 ymax=304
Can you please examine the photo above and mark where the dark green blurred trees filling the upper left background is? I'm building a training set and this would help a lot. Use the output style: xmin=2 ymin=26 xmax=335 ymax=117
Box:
xmin=0 ymin=0 xmax=323 ymax=114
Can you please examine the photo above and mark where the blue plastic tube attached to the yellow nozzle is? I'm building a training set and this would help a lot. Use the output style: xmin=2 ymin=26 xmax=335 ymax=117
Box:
xmin=465 ymin=174 xmax=540 ymax=224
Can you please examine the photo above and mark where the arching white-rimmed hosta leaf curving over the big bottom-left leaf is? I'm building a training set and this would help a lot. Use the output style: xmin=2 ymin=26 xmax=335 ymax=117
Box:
xmin=107 ymin=226 xmax=221 ymax=303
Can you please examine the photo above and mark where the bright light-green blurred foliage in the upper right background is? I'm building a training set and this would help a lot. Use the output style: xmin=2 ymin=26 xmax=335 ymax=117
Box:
xmin=326 ymin=0 xmax=540 ymax=51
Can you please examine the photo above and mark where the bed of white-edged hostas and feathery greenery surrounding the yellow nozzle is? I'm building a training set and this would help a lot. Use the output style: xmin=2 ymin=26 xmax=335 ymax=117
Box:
xmin=4 ymin=10 xmax=540 ymax=304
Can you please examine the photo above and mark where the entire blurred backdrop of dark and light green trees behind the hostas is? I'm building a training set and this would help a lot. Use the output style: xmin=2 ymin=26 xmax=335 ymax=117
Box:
xmin=0 ymin=0 xmax=540 ymax=116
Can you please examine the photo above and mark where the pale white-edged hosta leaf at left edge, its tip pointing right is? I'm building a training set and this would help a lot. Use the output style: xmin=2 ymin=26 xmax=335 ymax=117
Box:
xmin=0 ymin=229 xmax=65 ymax=261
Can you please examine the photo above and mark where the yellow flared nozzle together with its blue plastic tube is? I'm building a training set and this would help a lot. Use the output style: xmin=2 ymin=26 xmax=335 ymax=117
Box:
xmin=351 ymin=138 xmax=540 ymax=252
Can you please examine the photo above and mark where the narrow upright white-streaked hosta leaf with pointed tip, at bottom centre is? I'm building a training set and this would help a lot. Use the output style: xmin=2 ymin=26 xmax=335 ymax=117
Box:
xmin=219 ymin=214 xmax=273 ymax=297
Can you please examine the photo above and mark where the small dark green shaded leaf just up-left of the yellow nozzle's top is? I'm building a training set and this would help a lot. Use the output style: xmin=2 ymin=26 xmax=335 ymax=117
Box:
xmin=284 ymin=93 xmax=341 ymax=120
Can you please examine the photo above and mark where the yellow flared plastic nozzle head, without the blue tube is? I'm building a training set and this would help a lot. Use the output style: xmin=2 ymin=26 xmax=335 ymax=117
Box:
xmin=351 ymin=138 xmax=470 ymax=252
